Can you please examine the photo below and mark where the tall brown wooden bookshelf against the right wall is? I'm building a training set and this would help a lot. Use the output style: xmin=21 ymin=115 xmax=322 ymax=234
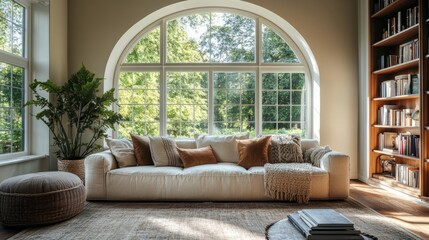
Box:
xmin=368 ymin=0 xmax=429 ymax=198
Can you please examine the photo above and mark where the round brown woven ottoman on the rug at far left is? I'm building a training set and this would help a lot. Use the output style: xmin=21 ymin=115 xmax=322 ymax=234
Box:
xmin=0 ymin=172 xmax=85 ymax=226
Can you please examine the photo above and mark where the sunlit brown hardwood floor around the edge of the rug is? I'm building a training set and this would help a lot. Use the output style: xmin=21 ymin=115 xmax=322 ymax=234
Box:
xmin=0 ymin=180 xmax=429 ymax=239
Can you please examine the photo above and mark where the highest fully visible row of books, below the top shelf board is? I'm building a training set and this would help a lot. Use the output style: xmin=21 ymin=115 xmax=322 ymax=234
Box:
xmin=381 ymin=6 xmax=419 ymax=39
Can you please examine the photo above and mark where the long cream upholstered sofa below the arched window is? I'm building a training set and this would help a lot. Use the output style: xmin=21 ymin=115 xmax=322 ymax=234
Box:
xmin=85 ymin=140 xmax=350 ymax=201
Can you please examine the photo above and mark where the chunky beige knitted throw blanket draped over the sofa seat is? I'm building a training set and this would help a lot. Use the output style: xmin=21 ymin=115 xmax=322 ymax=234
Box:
xmin=264 ymin=163 xmax=311 ymax=203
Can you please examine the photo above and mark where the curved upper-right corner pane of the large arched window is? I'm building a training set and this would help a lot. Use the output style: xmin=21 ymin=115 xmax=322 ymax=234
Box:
xmin=262 ymin=25 xmax=300 ymax=63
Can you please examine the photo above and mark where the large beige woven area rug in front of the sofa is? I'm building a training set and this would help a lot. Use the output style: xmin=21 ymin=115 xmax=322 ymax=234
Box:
xmin=10 ymin=198 xmax=418 ymax=240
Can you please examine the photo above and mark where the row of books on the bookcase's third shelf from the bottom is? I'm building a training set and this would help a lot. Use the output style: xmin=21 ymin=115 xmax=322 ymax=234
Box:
xmin=377 ymin=105 xmax=419 ymax=127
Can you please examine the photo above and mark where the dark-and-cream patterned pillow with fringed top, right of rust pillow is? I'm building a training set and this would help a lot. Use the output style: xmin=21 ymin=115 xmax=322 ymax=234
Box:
xmin=268 ymin=135 xmax=304 ymax=163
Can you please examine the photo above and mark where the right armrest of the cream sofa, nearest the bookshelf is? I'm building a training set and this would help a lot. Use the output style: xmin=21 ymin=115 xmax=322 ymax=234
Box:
xmin=320 ymin=151 xmax=350 ymax=199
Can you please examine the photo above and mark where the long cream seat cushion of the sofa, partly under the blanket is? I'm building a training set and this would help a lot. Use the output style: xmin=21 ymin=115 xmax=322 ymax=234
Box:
xmin=106 ymin=163 xmax=329 ymax=201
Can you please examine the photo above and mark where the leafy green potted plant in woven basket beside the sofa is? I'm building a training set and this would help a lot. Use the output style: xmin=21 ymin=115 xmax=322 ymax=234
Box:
xmin=25 ymin=65 xmax=121 ymax=180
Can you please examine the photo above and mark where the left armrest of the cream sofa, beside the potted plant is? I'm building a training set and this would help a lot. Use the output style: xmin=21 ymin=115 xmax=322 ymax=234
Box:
xmin=85 ymin=151 xmax=118 ymax=200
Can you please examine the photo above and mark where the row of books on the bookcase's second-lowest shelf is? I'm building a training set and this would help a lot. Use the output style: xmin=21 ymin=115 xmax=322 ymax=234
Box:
xmin=378 ymin=132 xmax=421 ymax=157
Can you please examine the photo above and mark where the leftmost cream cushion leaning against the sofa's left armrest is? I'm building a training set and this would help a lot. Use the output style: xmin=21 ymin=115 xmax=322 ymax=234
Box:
xmin=106 ymin=138 xmax=137 ymax=167
